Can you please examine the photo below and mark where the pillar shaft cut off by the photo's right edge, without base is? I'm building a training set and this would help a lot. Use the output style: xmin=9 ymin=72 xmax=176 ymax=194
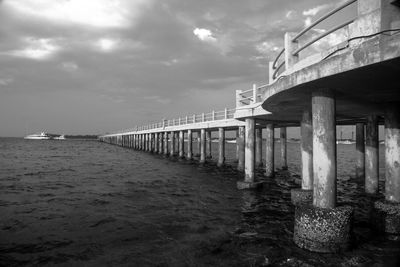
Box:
xmin=385 ymin=103 xmax=400 ymax=203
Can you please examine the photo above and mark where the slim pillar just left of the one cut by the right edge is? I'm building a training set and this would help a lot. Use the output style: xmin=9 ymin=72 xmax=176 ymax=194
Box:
xmin=365 ymin=114 xmax=379 ymax=194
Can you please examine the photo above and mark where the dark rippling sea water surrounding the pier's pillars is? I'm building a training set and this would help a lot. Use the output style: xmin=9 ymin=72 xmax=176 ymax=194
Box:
xmin=0 ymin=138 xmax=400 ymax=266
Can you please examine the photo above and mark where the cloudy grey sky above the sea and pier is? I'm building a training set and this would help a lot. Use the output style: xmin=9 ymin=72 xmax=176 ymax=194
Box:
xmin=0 ymin=0 xmax=356 ymax=136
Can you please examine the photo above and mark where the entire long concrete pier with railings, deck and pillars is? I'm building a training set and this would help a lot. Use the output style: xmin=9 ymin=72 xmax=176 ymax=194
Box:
xmin=99 ymin=0 xmax=400 ymax=252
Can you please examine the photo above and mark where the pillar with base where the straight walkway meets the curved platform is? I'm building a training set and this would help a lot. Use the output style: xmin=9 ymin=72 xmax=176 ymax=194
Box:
xmin=237 ymin=118 xmax=262 ymax=189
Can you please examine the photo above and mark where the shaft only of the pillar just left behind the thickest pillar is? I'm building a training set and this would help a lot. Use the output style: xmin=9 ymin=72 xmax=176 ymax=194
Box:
xmin=300 ymin=108 xmax=314 ymax=191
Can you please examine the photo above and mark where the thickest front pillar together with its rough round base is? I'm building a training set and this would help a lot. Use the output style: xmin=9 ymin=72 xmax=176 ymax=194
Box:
xmin=293 ymin=89 xmax=354 ymax=253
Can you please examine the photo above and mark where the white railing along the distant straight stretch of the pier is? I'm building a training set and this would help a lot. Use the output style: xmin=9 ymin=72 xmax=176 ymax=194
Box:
xmin=108 ymin=108 xmax=236 ymax=135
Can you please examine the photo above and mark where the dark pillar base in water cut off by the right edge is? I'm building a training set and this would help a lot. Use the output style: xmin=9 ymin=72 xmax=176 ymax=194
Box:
xmin=374 ymin=200 xmax=400 ymax=240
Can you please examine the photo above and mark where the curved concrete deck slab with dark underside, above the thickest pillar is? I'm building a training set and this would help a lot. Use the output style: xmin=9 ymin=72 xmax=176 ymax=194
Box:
xmin=262 ymin=34 xmax=400 ymax=122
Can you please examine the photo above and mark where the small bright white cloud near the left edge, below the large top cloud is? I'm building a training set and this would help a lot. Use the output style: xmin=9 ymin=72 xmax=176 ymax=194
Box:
xmin=3 ymin=37 xmax=61 ymax=60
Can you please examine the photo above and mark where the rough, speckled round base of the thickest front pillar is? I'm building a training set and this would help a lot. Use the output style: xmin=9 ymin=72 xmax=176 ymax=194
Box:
xmin=293 ymin=205 xmax=353 ymax=253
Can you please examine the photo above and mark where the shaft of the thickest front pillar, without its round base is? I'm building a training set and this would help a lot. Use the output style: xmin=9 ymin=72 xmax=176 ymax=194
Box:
xmin=312 ymin=89 xmax=336 ymax=208
